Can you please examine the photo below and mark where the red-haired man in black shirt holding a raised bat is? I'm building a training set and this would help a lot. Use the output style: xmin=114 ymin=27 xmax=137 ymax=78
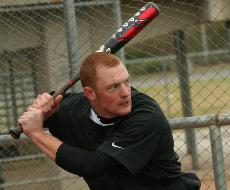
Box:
xmin=18 ymin=52 xmax=200 ymax=190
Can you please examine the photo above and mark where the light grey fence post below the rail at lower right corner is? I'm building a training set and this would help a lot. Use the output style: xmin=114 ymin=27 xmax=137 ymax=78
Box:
xmin=209 ymin=125 xmax=227 ymax=190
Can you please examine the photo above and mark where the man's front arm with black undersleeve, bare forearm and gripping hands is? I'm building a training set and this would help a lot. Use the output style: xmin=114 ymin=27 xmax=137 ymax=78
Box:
xmin=18 ymin=94 xmax=121 ymax=177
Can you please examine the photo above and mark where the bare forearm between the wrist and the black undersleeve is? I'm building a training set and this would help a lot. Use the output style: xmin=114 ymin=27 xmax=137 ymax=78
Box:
xmin=30 ymin=131 xmax=63 ymax=160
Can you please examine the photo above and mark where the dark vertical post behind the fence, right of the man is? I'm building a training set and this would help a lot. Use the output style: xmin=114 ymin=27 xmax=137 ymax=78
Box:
xmin=175 ymin=30 xmax=198 ymax=169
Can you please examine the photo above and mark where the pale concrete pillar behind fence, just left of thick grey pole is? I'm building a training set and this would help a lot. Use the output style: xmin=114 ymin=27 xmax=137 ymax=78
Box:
xmin=41 ymin=19 xmax=69 ymax=90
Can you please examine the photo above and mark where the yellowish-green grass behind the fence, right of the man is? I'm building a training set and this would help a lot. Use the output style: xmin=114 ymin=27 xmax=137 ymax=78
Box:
xmin=139 ymin=68 xmax=230 ymax=118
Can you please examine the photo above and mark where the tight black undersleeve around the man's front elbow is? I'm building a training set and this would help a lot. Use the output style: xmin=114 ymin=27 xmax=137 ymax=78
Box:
xmin=55 ymin=143 xmax=122 ymax=178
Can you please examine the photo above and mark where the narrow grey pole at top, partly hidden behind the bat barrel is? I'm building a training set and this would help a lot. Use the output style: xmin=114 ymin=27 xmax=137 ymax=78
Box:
xmin=113 ymin=0 xmax=125 ymax=64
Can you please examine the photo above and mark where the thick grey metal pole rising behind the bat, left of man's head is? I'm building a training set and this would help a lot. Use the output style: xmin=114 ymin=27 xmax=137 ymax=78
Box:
xmin=63 ymin=0 xmax=80 ymax=92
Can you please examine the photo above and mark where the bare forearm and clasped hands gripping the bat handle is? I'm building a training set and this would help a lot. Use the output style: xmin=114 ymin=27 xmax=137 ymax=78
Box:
xmin=18 ymin=93 xmax=63 ymax=160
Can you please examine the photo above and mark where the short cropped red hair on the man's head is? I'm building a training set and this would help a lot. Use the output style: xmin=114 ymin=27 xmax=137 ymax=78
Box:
xmin=80 ymin=52 xmax=121 ymax=87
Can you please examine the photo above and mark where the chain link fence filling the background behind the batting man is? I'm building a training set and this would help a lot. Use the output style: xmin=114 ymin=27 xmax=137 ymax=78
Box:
xmin=0 ymin=0 xmax=230 ymax=190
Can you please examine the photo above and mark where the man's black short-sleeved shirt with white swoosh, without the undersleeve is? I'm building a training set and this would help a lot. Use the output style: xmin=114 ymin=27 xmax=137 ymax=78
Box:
xmin=46 ymin=89 xmax=181 ymax=190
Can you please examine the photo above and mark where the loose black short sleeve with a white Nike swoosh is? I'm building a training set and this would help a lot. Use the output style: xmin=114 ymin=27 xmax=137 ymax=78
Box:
xmin=99 ymin=110 xmax=169 ymax=174
